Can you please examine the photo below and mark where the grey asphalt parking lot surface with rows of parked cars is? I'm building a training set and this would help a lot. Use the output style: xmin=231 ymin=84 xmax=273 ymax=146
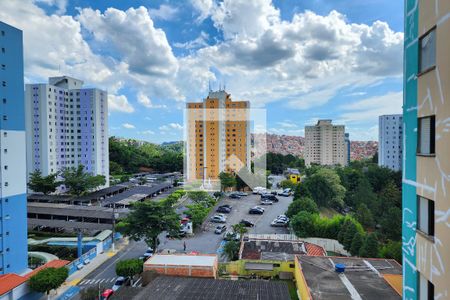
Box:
xmin=159 ymin=194 xmax=292 ymax=260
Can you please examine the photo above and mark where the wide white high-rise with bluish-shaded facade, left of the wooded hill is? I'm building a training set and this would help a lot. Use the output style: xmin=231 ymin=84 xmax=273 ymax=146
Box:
xmin=25 ymin=76 xmax=109 ymax=186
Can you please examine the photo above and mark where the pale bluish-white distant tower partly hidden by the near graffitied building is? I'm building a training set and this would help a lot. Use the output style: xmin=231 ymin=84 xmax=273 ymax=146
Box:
xmin=378 ymin=115 xmax=403 ymax=171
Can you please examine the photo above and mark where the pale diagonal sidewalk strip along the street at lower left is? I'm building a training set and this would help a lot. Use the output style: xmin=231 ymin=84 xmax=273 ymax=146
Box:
xmin=52 ymin=238 xmax=129 ymax=300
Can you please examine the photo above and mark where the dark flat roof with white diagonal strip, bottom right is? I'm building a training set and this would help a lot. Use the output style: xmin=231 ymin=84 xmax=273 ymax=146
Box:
xmin=297 ymin=256 xmax=402 ymax=300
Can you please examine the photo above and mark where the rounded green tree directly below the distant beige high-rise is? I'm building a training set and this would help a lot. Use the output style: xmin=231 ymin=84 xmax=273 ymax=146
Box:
xmin=303 ymin=168 xmax=345 ymax=207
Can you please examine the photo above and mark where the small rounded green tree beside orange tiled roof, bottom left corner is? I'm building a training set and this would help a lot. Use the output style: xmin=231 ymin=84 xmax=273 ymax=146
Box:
xmin=28 ymin=267 xmax=69 ymax=296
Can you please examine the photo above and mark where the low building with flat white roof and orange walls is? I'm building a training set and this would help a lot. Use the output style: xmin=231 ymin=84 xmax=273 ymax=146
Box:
xmin=144 ymin=254 xmax=218 ymax=278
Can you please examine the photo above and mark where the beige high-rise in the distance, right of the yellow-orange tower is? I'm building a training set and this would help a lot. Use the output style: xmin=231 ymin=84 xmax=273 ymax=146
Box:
xmin=305 ymin=120 xmax=347 ymax=166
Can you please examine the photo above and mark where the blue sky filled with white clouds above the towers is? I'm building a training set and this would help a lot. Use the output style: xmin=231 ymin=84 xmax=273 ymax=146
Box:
xmin=0 ymin=0 xmax=403 ymax=143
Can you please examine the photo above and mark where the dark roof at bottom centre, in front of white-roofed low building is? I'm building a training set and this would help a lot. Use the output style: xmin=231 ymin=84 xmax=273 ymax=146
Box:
xmin=112 ymin=276 xmax=290 ymax=300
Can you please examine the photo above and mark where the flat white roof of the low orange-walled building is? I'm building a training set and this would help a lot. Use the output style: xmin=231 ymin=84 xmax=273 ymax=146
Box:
xmin=145 ymin=254 xmax=217 ymax=266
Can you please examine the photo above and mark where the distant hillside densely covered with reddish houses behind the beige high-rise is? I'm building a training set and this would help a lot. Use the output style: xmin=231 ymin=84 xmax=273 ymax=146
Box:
xmin=252 ymin=134 xmax=378 ymax=160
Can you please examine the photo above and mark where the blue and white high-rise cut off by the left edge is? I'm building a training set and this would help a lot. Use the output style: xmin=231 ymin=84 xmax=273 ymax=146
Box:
xmin=0 ymin=22 xmax=28 ymax=274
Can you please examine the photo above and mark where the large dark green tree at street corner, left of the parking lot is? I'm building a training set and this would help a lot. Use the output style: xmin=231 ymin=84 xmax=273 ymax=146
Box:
xmin=116 ymin=200 xmax=180 ymax=252
